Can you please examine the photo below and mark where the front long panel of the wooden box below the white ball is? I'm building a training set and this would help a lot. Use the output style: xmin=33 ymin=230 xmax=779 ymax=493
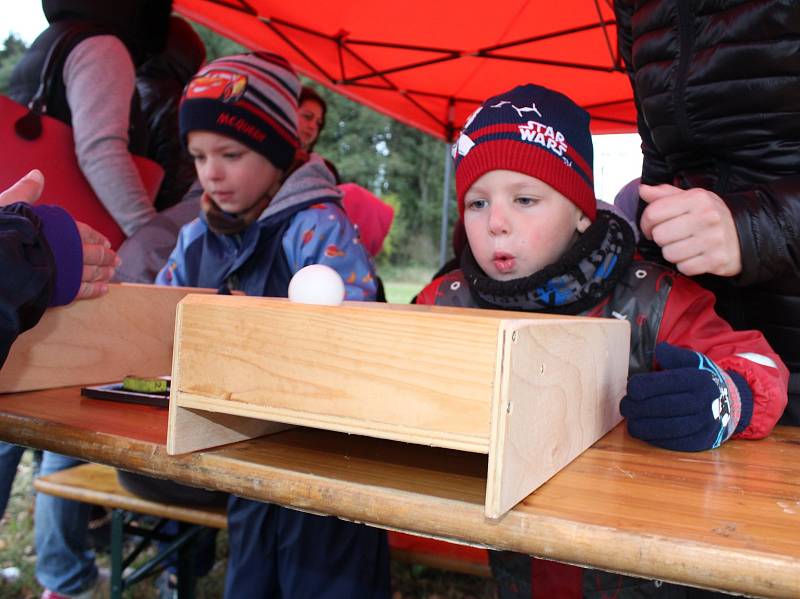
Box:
xmin=173 ymin=296 xmax=498 ymax=453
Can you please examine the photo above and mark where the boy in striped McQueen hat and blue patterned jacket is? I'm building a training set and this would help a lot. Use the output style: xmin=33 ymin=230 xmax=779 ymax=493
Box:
xmin=156 ymin=53 xmax=389 ymax=599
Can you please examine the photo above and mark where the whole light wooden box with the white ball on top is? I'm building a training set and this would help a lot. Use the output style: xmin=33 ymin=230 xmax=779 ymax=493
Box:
xmin=167 ymin=296 xmax=630 ymax=518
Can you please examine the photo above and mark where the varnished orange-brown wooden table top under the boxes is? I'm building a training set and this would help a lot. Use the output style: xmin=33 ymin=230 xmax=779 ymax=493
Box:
xmin=0 ymin=388 xmax=800 ymax=597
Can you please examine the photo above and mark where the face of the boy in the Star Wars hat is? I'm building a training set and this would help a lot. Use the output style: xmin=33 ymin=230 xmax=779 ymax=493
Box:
xmin=464 ymin=170 xmax=591 ymax=281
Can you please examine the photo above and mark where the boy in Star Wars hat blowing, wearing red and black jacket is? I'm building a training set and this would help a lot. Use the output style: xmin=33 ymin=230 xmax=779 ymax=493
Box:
xmin=417 ymin=85 xmax=788 ymax=599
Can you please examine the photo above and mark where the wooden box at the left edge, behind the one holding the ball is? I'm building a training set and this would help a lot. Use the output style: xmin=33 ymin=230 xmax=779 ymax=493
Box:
xmin=0 ymin=284 xmax=215 ymax=393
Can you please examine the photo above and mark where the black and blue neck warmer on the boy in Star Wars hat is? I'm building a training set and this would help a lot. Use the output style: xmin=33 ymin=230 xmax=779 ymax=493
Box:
xmin=461 ymin=210 xmax=636 ymax=314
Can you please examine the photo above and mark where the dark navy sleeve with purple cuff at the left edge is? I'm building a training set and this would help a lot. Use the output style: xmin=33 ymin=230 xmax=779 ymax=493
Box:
xmin=0 ymin=203 xmax=83 ymax=366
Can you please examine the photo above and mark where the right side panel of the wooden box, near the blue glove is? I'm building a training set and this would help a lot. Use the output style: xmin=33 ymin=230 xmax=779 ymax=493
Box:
xmin=486 ymin=319 xmax=630 ymax=518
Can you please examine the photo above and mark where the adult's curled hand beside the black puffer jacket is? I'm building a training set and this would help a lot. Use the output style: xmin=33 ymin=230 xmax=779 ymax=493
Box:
xmin=639 ymin=184 xmax=742 ymax=277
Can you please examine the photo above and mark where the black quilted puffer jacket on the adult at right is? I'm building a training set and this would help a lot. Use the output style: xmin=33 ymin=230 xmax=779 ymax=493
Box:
xmin=615 ymin=0 xmax=800 ymax=421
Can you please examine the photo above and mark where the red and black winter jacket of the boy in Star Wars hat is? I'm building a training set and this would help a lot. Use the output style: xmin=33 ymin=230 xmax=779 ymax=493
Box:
xmin=416 ymin=255 xmax=788 ymax=599
